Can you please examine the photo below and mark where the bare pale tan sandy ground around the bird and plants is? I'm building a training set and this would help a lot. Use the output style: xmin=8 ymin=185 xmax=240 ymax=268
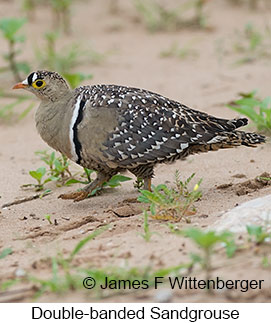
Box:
xmin=0 ymin=0 xmax=271 ymax=302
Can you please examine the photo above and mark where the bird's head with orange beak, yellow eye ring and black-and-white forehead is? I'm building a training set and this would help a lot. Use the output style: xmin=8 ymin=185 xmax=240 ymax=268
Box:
xmin=13 ymin=71 xmax=70 ymax=101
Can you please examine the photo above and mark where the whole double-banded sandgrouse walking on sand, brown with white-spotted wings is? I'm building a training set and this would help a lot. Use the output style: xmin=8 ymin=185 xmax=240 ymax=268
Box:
xmin=13 ymin=70 xmax=265 ymax=201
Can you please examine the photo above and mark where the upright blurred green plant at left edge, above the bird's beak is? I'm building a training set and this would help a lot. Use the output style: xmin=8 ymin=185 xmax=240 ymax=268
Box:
xmin=0 ymin=18 xmax=30 ymax=82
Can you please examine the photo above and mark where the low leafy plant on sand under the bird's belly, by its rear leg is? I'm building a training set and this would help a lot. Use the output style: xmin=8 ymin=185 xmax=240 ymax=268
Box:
xmin=138 ymin=171 xmax=202 ymax=222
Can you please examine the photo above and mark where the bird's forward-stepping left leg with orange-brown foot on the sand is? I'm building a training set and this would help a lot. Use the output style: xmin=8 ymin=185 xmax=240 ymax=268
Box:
xmin=58 ymin=173 xmax=115 ymax=202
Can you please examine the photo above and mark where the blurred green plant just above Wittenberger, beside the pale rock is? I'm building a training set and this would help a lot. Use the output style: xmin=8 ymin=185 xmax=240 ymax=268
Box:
xmin=169 ymin=225 xmax=236 ymax=280
